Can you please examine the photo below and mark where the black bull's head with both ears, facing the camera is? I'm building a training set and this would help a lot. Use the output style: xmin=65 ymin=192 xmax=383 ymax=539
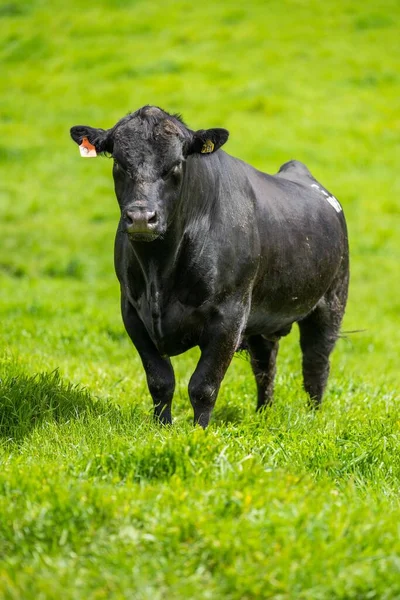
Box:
xmin=71 ymin=106 xmax=229 ymax=241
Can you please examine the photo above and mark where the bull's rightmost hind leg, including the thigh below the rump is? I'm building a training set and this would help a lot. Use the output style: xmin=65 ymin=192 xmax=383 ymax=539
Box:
xmin=299 ymin=274 xmax=348 ymax=408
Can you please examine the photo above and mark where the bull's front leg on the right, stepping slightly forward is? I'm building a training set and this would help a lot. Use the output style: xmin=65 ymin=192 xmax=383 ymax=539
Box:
xmin=189 ymin=303 xmax=247 ymax=428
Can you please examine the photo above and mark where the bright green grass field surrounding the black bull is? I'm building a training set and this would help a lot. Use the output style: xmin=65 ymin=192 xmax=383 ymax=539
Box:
xmin=0 ymin=0 xmax=400 ymax=600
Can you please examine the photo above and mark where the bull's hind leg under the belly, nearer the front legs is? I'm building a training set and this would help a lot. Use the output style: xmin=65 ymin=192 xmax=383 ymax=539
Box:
xmin=247 ymin=335 xmax=279 ymax=410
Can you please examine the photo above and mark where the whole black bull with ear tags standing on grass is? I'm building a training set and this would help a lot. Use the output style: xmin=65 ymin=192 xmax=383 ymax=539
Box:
xmin=71 ymin=106 xmax=349 ymax=427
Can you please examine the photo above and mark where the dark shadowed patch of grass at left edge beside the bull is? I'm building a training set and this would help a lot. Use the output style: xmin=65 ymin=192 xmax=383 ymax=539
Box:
xmin=0 ymin=370 xmax=128 ymax=441
